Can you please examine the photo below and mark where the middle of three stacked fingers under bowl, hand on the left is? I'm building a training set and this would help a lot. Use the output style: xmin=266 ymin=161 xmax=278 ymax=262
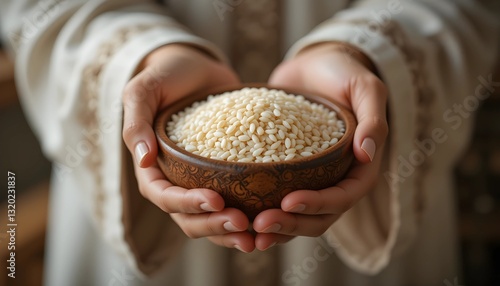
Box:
xmin=171 ymin=208 xmax=249 ymax=238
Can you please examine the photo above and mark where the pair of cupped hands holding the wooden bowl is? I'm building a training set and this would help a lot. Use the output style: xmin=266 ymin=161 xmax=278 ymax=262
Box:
xmin=123 ymin=43 xmax=388 ymax=252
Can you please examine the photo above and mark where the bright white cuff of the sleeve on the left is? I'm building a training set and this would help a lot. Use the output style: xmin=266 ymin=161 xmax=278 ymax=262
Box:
xmin=94 ymin=27 xmax=226 ymax=275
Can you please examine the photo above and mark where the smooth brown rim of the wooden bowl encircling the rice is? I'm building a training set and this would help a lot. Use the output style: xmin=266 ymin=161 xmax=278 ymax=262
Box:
xmin=154 ymin=83 xmax=357 ymax=168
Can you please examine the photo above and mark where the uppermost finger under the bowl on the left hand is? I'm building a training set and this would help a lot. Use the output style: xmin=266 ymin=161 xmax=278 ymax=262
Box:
xmin=135 ymin=165 xmax=224 ymax=213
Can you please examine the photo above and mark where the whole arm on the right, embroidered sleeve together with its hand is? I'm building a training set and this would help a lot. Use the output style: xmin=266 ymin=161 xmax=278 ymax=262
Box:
xmin=254 ymin=0 xmax=499 ymax=274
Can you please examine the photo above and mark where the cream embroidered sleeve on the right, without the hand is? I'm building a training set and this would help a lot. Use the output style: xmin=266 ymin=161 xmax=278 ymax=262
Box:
xmin=288 ymin=0 xmax=498 ymax=274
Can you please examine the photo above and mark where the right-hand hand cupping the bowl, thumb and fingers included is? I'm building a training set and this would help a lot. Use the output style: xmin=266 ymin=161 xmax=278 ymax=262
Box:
xmin=253 ymin=43 xmax=388 ymax=250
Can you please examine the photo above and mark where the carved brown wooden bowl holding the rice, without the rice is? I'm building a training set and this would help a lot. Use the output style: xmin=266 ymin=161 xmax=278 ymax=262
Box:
xmin=155 ymin=84 xmax=356 ymax=220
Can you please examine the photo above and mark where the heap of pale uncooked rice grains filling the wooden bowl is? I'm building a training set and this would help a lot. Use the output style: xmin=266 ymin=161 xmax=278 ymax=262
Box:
xmin=167 ymin=88 xmax=345 ymax=162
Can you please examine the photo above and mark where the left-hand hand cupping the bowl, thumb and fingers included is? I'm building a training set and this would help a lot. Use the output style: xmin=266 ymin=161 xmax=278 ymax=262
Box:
xmin=123 ymin=44 xmax=255 ymax=252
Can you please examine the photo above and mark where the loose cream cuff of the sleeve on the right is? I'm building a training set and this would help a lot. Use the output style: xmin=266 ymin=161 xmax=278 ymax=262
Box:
xmin=287 ymin=19 xmax=418 ymax=275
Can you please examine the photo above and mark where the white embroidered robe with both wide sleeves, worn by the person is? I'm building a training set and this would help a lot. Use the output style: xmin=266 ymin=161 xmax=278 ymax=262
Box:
xmin=0 ymin=0 xmax=500 ymax=286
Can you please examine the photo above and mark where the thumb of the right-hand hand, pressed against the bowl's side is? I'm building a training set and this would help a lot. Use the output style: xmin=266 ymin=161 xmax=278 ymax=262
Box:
xmin=350 ymin=75 xmax=389 ymax=163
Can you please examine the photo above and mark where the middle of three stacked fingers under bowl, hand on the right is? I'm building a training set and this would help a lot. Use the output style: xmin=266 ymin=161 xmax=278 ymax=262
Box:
xmin=253 ymin=209 xmax=340 ymax=237
